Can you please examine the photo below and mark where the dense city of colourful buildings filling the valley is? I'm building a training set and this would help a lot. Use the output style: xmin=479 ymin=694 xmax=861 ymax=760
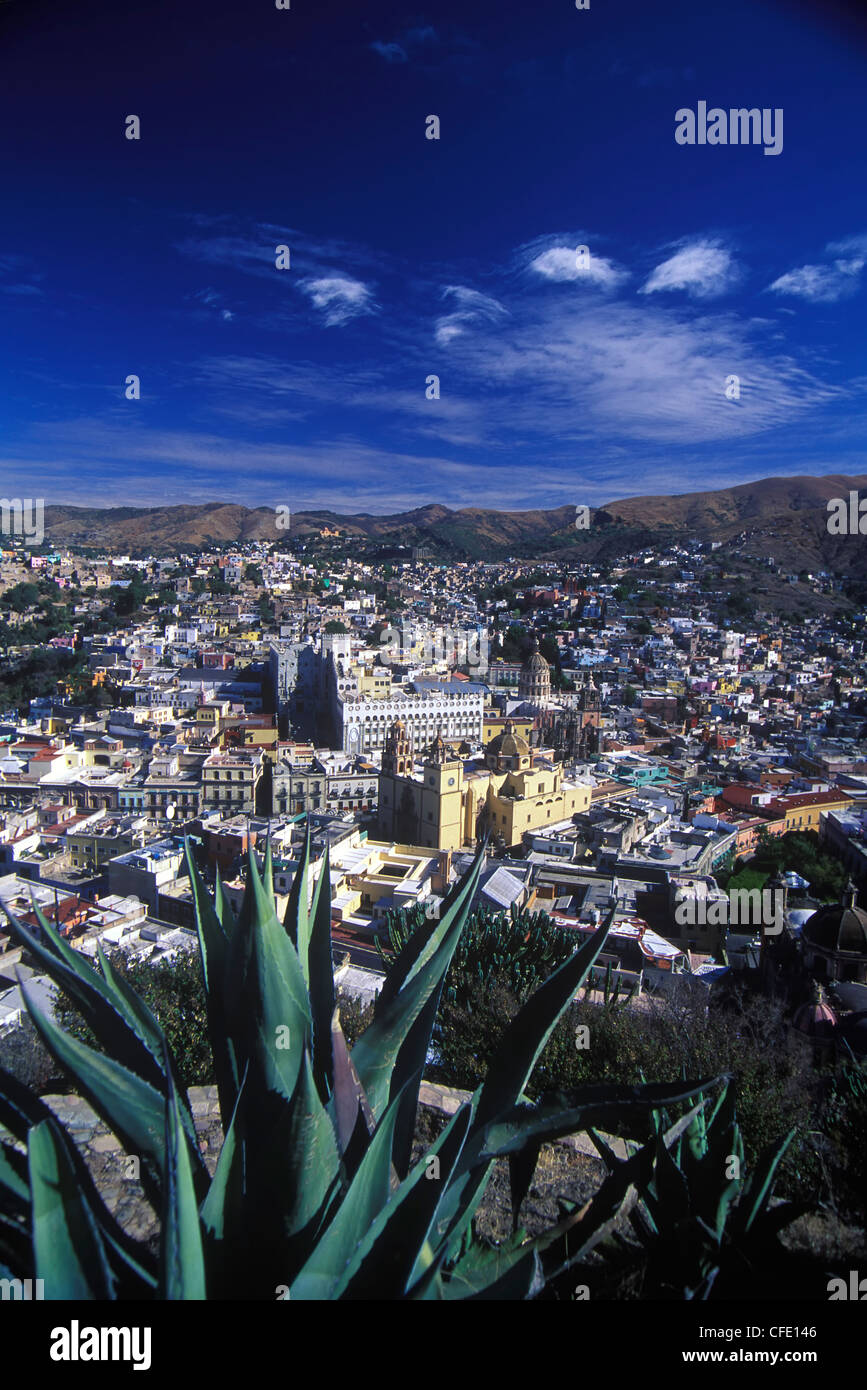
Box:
xmin=0 ymin=530 xmax=867 ymax=1061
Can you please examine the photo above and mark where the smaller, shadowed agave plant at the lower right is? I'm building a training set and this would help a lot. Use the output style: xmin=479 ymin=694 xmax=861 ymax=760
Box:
xmin=593 ymin=1086 xmax=810 ymax=1300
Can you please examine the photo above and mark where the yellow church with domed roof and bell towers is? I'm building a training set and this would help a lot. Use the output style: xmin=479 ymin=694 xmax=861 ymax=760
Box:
xmin=379 ymin=720 xmax=591 ymax=849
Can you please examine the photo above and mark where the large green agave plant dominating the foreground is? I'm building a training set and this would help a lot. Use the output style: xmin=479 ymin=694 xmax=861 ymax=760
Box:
xmin=0 ymin=831 xmax=713 ymax=1300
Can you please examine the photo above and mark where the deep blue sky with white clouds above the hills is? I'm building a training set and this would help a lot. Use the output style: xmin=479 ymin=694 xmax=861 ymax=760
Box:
xmin=0 ymin=0 xmax=867 ymax=512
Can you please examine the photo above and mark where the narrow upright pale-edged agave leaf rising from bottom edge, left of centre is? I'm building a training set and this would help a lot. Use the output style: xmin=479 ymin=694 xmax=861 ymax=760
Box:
xmin=160 ymin=1047 xmax=206 ymax=1301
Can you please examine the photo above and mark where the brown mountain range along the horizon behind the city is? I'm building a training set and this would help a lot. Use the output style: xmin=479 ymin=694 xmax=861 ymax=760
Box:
xmin=38 ymin=474 xmax=867 ymax=577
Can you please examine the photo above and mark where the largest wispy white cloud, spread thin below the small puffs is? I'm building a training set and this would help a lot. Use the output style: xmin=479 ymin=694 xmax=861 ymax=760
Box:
xmin=430 ymin=289 xmax=846 ymax=449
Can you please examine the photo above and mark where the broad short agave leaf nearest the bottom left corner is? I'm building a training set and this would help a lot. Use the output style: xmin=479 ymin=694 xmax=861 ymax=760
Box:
xmin=28 ymin=1120 xmax=115 ymax=1300
